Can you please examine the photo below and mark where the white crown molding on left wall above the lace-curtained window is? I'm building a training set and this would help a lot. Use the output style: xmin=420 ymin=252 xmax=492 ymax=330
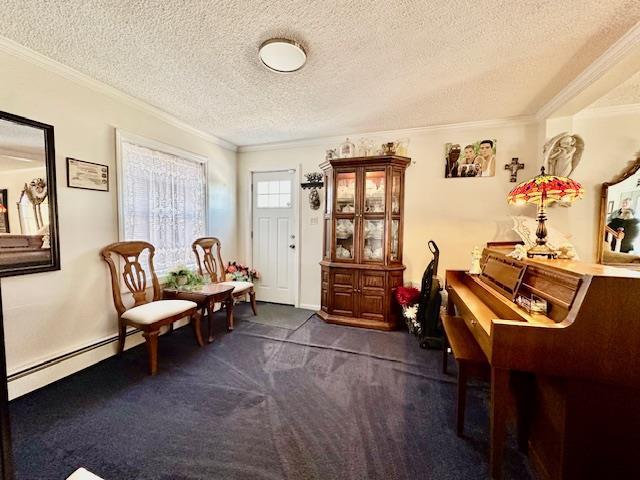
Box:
xmin=0 ymin=36 xmax=238 ymax=152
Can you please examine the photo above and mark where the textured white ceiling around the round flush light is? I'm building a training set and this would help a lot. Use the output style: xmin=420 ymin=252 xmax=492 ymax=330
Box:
xmin=0 ymin=0 xmax=640 ymax=145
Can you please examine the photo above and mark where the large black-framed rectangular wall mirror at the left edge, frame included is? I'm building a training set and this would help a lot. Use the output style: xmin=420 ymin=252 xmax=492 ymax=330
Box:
xmin=0 ymin=112 xmax=60 ymax=277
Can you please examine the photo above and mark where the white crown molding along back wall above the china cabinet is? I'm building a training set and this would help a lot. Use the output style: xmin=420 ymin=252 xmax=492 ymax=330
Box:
xmin=238 ymin=115 xmax=538 ymax=153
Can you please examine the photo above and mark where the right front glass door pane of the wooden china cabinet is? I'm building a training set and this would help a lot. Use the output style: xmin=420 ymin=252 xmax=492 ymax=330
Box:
xmin=362 ymin=169 xmax=386 ymax=262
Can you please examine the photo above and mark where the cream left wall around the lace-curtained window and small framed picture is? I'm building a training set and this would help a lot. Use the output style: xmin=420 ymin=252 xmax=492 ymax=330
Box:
xmin=0 ymin=51 xmax=237 ymax=397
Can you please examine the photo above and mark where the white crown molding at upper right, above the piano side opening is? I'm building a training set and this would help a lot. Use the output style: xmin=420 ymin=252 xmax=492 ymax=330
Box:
xmin=536 ymin=22 xmax=640 ymax=120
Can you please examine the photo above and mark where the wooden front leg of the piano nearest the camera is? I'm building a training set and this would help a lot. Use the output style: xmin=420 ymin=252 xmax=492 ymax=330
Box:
xmin=489 ymin=368 xmax=509 ymax=480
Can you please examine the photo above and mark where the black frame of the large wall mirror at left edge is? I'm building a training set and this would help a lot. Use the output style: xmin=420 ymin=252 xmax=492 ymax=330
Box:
xmin=0 ymin=111 xmax=60 ymax=277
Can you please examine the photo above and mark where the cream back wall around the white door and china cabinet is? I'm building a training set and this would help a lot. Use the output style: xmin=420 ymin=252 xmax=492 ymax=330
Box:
xmin=238 ymin=121 xmax=540 ymax=308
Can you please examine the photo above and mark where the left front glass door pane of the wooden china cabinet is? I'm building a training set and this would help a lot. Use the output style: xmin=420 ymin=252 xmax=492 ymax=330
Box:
xmin=335 ymin=170 xmax=357 ymax=260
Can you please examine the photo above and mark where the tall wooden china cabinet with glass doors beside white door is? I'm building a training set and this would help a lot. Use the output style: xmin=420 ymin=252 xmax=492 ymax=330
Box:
xmin=318 ymin=155 xmax=411 ymax=330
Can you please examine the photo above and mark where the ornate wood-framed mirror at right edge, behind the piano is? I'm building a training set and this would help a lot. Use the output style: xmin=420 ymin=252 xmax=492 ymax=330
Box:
xmin=598 ymin=158 xmax=640 ymax=270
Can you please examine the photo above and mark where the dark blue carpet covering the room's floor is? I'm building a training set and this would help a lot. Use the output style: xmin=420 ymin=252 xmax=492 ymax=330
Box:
xmin=11 ymin=304 xmax=531 ymax=480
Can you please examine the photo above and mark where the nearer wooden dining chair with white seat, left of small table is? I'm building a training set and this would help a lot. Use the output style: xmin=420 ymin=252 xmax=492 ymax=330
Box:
xmin=100 ymin=241 xmax=204 ymax=375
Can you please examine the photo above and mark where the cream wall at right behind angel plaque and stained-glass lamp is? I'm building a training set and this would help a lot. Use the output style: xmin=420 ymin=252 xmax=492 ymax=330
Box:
xmin=547 ymin=109 xmax=640 ymax=262
